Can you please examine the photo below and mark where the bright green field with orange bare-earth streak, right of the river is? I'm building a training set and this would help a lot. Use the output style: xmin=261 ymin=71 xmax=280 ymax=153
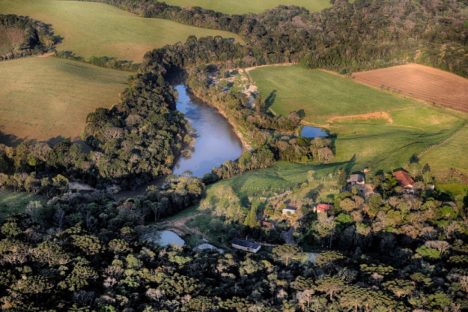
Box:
xmin=250 ymin=66 xmax=468 ymax=173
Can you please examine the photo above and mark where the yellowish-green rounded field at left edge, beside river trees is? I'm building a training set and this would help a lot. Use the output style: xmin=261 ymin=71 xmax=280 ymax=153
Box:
xmin=0 ymin=57 xmax=129 ymax=143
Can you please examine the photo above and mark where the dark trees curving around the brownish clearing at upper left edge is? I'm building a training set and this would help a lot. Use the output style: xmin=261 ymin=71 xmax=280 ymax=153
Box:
xmin=0 ymin=14 xmax=60 ymax=61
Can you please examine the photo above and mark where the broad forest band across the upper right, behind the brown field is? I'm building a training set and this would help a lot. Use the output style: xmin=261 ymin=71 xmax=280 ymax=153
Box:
xmin=84 ymin=0 xmax=468 ymax=76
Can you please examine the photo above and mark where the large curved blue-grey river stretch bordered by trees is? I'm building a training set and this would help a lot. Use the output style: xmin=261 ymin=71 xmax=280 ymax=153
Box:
xmin=174 ymin=85 xmax=242 ymax=177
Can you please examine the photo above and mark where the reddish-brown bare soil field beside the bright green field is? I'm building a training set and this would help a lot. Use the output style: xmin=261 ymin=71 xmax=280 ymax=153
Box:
xmin=352 ymin=64 xmax=468 ymax=112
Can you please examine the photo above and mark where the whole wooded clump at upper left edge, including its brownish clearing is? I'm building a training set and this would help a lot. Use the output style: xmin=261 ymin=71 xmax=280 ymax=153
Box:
xmin=0 ymin=14 xmax=60 ymax=61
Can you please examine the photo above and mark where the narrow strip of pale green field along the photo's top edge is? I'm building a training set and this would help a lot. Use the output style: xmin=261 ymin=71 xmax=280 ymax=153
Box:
xmin=164 ymin=0 xmax=331 ymax=14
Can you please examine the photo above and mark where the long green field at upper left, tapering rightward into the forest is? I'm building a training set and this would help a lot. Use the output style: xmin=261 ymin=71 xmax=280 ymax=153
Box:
xmin=0 ymin=0 xmax=240 ymax=62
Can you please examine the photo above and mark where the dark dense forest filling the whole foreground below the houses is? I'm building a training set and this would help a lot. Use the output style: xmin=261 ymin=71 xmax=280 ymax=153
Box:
xmin=0 ymin=165 xmax=468 ymax=311
